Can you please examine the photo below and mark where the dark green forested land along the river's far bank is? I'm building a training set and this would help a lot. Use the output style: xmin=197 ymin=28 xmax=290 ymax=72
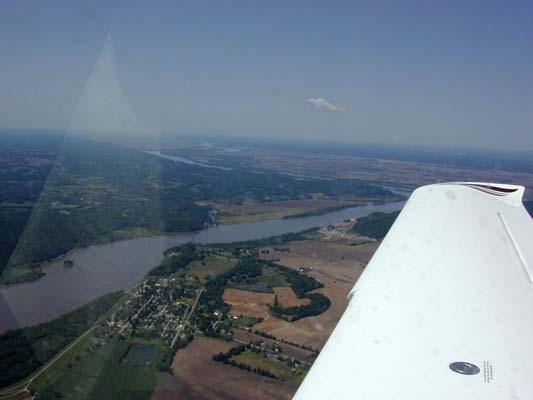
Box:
xmin=0 ymin=134 xmax=394 ymax=282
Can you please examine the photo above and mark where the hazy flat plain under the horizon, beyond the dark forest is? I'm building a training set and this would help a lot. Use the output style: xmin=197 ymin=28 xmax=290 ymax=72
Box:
xmin=154 ymin=138 xmax=533 ymax=188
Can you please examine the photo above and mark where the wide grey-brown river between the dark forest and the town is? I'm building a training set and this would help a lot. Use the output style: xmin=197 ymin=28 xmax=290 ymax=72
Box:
xmin=0 ymin=202 xmax=404 ymax=333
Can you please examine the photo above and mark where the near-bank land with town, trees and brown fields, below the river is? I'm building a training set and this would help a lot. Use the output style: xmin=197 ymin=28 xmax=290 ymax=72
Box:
xmin=0 ymin=214 xmax=390 ymax=399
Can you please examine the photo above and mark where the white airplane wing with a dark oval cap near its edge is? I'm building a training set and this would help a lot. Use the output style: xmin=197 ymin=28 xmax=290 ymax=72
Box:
xmin=294 ymin=183 xmax=533 ymax=400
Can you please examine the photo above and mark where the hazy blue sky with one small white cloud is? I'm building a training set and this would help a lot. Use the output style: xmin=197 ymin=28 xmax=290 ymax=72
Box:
xmin=0 ymin=0 xmax=533 ymax=149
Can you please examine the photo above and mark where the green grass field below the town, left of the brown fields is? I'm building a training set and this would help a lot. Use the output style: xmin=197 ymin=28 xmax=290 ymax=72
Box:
xmin=20 ymin=294 xmax=165 ymax=400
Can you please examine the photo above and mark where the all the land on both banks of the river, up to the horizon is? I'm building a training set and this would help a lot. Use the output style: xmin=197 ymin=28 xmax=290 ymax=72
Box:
xmin=0 ymin=133 xmax=533 ymax=400
